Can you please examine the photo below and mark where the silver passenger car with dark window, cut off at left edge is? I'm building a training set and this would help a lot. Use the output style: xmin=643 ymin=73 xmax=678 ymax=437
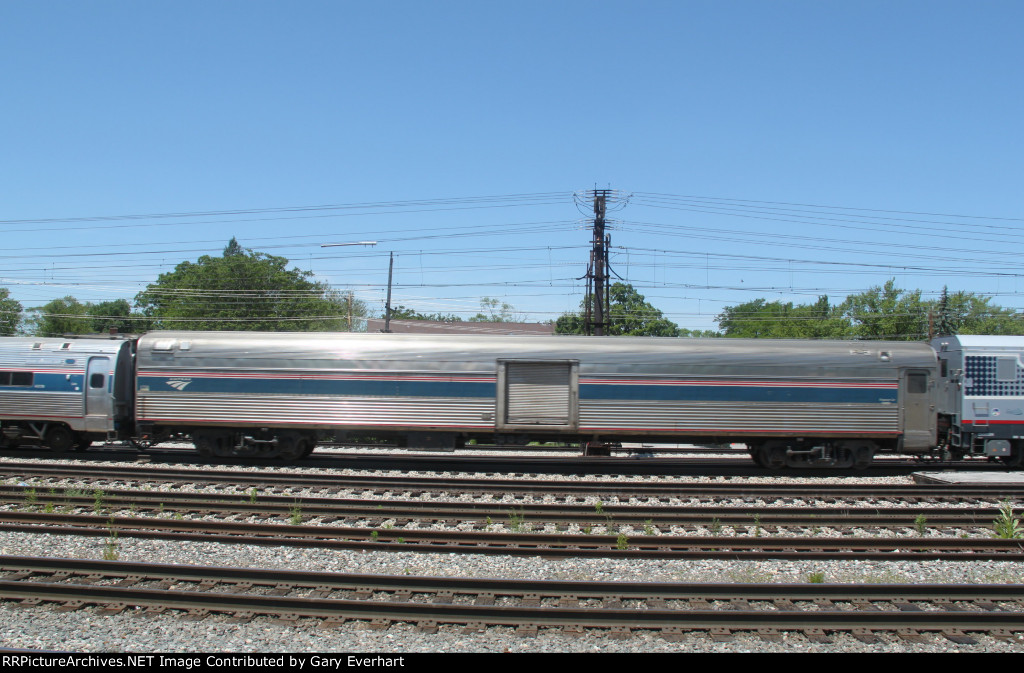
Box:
xmin=0 ymin=337 xmax=134 ymax=451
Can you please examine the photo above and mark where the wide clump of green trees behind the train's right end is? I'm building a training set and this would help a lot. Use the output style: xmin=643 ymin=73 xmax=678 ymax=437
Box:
xmin=716 ymin=279 xmax=1024 ymax=341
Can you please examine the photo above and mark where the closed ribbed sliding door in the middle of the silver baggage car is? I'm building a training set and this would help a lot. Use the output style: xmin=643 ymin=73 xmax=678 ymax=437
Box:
xmin=495 ymin=360 xmax=580 ymax=430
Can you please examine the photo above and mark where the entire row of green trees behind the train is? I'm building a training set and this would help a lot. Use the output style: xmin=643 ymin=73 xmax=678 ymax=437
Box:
xmin=0 ymin=238 xmax=1024 ymax=341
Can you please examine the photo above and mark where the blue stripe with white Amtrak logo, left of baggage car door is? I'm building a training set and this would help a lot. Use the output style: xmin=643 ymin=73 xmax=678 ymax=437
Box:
xmin=138 ymin=376 xmax=496 ymax=399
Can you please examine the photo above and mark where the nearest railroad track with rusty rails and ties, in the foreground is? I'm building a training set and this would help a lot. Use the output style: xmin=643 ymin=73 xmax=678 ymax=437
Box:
xmin=0 ymin=556 xmax=1024 ymax=644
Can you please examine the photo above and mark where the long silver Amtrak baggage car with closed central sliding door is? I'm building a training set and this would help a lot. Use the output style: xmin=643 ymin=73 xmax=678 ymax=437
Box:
xmin=136 ymin=332 xmax=937 ymax=467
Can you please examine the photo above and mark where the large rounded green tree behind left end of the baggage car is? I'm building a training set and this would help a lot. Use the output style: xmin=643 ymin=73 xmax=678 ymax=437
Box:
xmin=135 ymin=239 xmax=366 ymax=331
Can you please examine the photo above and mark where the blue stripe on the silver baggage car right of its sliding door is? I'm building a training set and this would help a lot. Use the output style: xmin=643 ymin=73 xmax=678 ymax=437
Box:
xmin=580 ymin=382 xmax=896 ymax=405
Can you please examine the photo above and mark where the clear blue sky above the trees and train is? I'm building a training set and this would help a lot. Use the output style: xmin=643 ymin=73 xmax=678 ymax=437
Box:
xmin=0 ymin=0 xmax=1024 ymax=329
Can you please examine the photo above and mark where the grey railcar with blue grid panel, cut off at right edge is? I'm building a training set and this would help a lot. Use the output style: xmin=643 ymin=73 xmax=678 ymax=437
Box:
xmin=932 ymin=335 xmax=1024 ymax=467
